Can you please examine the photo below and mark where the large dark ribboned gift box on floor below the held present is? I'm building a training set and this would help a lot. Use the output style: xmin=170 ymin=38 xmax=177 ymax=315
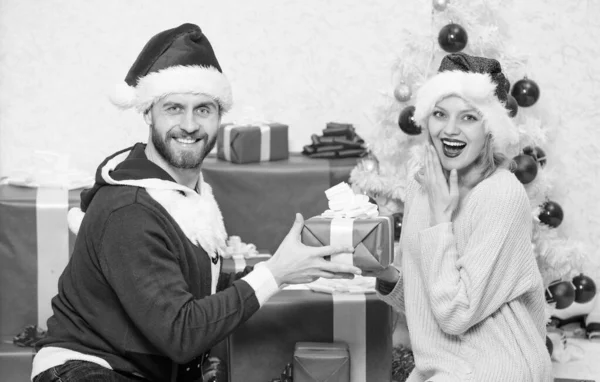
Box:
xmin=228 ymin=289 xmax=393 ymax=382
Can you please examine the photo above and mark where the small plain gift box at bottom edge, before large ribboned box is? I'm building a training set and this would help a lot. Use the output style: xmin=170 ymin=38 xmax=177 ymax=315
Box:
xmin=293 ymin=342 xmax=351 ymax=382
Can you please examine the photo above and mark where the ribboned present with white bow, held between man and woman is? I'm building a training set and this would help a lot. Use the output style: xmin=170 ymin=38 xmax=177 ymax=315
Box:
xmin=302 ymin=183 xmax=394 ymax=276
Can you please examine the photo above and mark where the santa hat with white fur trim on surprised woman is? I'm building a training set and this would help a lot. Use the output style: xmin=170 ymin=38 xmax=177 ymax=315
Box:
xmin=413 ymin=53 xmax=519 ymax=154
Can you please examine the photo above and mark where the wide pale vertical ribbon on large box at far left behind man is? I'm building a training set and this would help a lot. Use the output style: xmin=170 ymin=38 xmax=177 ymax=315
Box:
xmin=36 ymin=188 xmax=69 ymax=329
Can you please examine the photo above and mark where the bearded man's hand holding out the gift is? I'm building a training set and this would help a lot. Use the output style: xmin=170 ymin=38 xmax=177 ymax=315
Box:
xmin=264 ymin=214 xmax=361 ymax=285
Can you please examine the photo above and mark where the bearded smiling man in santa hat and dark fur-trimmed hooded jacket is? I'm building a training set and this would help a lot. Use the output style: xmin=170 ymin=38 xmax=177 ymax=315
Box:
xmin=32 ymin=24 xmax=360 ymax=382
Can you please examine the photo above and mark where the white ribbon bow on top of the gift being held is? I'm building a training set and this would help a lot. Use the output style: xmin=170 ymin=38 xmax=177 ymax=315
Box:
xmin=321 ymin=182 xmax=379 ymax=219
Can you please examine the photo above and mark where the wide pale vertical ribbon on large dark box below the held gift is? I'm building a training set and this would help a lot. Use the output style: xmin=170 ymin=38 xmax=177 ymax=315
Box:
xmin=332 ymin=293 xmax=368 ymax=382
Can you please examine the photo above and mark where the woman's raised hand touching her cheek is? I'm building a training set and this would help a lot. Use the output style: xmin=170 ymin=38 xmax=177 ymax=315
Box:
xmin=421 ymin=145 xmax=459 ymax=227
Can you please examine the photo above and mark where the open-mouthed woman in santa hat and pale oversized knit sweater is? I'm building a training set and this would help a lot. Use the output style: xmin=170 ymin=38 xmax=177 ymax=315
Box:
xmin=377 ymin=53 xmax=553 ymax=382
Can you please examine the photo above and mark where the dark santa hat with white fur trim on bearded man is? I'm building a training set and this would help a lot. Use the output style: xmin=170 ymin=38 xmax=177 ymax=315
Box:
xmin=110 ymin=24 xmax=233 ymax=112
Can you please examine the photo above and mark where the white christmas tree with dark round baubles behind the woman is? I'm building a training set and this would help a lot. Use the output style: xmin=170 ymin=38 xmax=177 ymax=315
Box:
xmin=350 ymin=0 xmax=600 ymax=312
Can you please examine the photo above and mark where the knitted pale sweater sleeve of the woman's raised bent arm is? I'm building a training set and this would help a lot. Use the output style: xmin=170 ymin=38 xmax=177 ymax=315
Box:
xmin=419 ymin=178 xmax=537 ymax=335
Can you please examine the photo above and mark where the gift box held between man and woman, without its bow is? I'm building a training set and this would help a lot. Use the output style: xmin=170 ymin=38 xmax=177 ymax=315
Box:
xmin=301 ymin=215 xmax=394 ymax=276
